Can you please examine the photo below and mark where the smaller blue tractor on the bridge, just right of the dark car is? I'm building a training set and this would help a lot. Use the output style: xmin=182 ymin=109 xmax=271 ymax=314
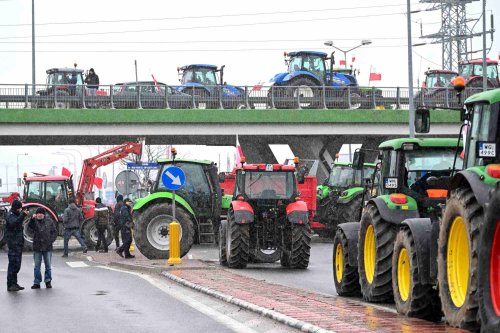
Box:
xmin=177 ymin=64 xmax=245 ymax=109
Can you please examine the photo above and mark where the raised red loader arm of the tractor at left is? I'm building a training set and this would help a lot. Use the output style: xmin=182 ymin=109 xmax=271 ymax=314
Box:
xmin=76 ymin=142 xmax=142 ymax=205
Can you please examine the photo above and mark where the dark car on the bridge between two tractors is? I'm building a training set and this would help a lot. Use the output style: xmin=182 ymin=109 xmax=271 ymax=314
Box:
xmin=113 ymin=81 xmax=192 ymax=109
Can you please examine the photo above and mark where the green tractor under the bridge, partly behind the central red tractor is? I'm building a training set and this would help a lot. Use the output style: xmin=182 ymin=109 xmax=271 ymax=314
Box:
xmin=314 ymin=162 xmax=375 ymax=237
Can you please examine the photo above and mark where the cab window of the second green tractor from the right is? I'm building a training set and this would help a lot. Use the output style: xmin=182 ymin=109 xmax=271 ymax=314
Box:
xmin=404 ymin=148 xmax=463 ymax=187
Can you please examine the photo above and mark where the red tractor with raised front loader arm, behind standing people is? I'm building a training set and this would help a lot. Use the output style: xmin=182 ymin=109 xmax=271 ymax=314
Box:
xmin=19 ymin=142 xmax=142 ymax=249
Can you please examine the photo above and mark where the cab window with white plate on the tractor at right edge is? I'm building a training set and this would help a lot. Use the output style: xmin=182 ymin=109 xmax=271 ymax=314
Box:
xmin=465 ymin=103 xmax=500 ymax=168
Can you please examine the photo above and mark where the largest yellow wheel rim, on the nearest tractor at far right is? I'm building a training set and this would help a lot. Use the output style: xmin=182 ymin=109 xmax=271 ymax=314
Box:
xmin=446 ymin=216 xmax=470 ymax=308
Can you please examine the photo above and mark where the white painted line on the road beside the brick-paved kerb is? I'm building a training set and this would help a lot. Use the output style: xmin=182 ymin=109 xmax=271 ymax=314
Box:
xmin=96 ymin=266 xmax=258 ymax=333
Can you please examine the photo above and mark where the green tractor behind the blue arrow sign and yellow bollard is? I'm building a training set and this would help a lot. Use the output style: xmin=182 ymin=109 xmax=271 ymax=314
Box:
xmin=134 ymin=159 xmax=222 ymax=259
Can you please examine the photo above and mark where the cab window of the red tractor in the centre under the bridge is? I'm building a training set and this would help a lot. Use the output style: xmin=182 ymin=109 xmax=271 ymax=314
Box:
xmin=235 ymin=170 xmax=296 ymax=199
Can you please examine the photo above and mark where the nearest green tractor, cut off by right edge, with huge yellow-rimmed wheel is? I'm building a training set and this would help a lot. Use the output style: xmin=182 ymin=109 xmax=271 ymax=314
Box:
xmin=392 ymin=89 xmax=500 ymax=332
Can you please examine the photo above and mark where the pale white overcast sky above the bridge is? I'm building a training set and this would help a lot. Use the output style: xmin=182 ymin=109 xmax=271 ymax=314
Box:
xmin=0 ymin=0 xmax=500 ymax=87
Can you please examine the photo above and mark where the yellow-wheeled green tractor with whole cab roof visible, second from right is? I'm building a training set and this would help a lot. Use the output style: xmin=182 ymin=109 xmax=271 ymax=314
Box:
xmin=333 ymin=138 xmax=457 ymax=302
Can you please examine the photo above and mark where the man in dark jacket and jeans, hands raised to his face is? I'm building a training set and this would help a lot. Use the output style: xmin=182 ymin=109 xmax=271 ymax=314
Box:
xmin=28 ymin=207 xmax=57 ymax=289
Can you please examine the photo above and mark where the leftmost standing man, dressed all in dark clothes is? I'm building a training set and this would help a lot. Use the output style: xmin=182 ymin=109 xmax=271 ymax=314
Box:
xmin=5 ymin=200 xmax=28 ymax=291
